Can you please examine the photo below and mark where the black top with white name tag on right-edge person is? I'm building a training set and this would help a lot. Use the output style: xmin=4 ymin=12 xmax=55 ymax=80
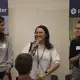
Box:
xmin=69 ymin=37 xmax=80 ymax=68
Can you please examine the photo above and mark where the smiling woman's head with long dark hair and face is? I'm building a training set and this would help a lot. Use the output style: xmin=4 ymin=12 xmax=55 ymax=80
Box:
xmin=35 ymin=25 xmax=53 ymax=49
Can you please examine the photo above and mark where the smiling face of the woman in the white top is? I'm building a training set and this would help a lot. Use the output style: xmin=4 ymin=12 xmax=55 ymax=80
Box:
xmin=35 ymin=28 xmax=46 ymax=42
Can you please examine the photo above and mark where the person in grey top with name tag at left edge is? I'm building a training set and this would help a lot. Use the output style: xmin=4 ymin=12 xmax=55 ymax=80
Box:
xmin=0 ymin=16 xmax=13 ymax=80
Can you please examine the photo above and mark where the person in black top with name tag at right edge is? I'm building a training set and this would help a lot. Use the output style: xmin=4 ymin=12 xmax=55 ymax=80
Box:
xmin=69 ymin=20 xmax=80 ymax=80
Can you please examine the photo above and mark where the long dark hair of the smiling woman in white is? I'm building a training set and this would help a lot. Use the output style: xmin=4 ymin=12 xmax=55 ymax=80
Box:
xmin=35 ymin=25 xmax=53 ymax=49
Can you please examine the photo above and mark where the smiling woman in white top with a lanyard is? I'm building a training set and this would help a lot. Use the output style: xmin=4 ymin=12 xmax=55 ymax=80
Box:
xmin=22 ymin=25 xmax=60 ymax=80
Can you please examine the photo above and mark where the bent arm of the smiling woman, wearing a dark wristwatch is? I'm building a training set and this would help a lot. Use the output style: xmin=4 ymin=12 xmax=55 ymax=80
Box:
xmin=39 ymin=48 xmax=60 ymax=79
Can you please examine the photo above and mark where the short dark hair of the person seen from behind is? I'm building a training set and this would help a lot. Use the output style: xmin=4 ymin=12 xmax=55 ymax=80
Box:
xmin=15 ymin=53 xmax=33 ymax=75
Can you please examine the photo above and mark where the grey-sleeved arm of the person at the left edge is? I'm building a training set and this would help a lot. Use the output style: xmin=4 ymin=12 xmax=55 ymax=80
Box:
xmin=3 ymin=37 xmax=13 ymax=80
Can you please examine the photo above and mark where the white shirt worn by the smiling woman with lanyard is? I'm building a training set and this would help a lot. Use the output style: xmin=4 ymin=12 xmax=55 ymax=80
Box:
xmin=22 ymin=43 xmax=60 ymax=80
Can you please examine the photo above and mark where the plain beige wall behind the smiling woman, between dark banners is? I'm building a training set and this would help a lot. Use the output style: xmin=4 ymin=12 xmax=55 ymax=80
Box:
xmin=8 ymin=0 xmax=69 ymax=80
